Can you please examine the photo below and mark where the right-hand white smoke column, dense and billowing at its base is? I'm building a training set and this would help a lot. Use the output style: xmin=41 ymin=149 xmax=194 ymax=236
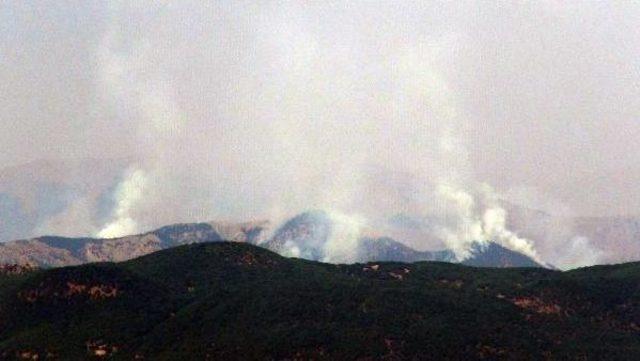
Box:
xmin=396 ymin=49 xmax=544 ymax=263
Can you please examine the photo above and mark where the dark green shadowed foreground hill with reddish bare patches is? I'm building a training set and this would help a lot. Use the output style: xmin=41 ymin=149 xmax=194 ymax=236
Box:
xmin=0 ymin=242 xmax=640 ymax=360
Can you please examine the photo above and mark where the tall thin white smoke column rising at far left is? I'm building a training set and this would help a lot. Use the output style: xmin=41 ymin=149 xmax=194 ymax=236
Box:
xmin=95 ymin=2 xmax=184 ymax=238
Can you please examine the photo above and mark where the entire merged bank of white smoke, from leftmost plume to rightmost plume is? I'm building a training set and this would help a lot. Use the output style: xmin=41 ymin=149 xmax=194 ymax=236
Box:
xmin=91 ymin=3 xmax=538 ymax=261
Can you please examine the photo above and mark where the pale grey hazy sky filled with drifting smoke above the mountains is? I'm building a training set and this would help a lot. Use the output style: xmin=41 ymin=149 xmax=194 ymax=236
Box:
xmin=0 ymin=0 xmax=640 ymax=215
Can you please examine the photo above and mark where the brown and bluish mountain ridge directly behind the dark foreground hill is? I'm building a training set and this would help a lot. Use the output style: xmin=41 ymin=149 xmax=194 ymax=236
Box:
xmin=0 ymin=211 xmax=541 ymax=267
